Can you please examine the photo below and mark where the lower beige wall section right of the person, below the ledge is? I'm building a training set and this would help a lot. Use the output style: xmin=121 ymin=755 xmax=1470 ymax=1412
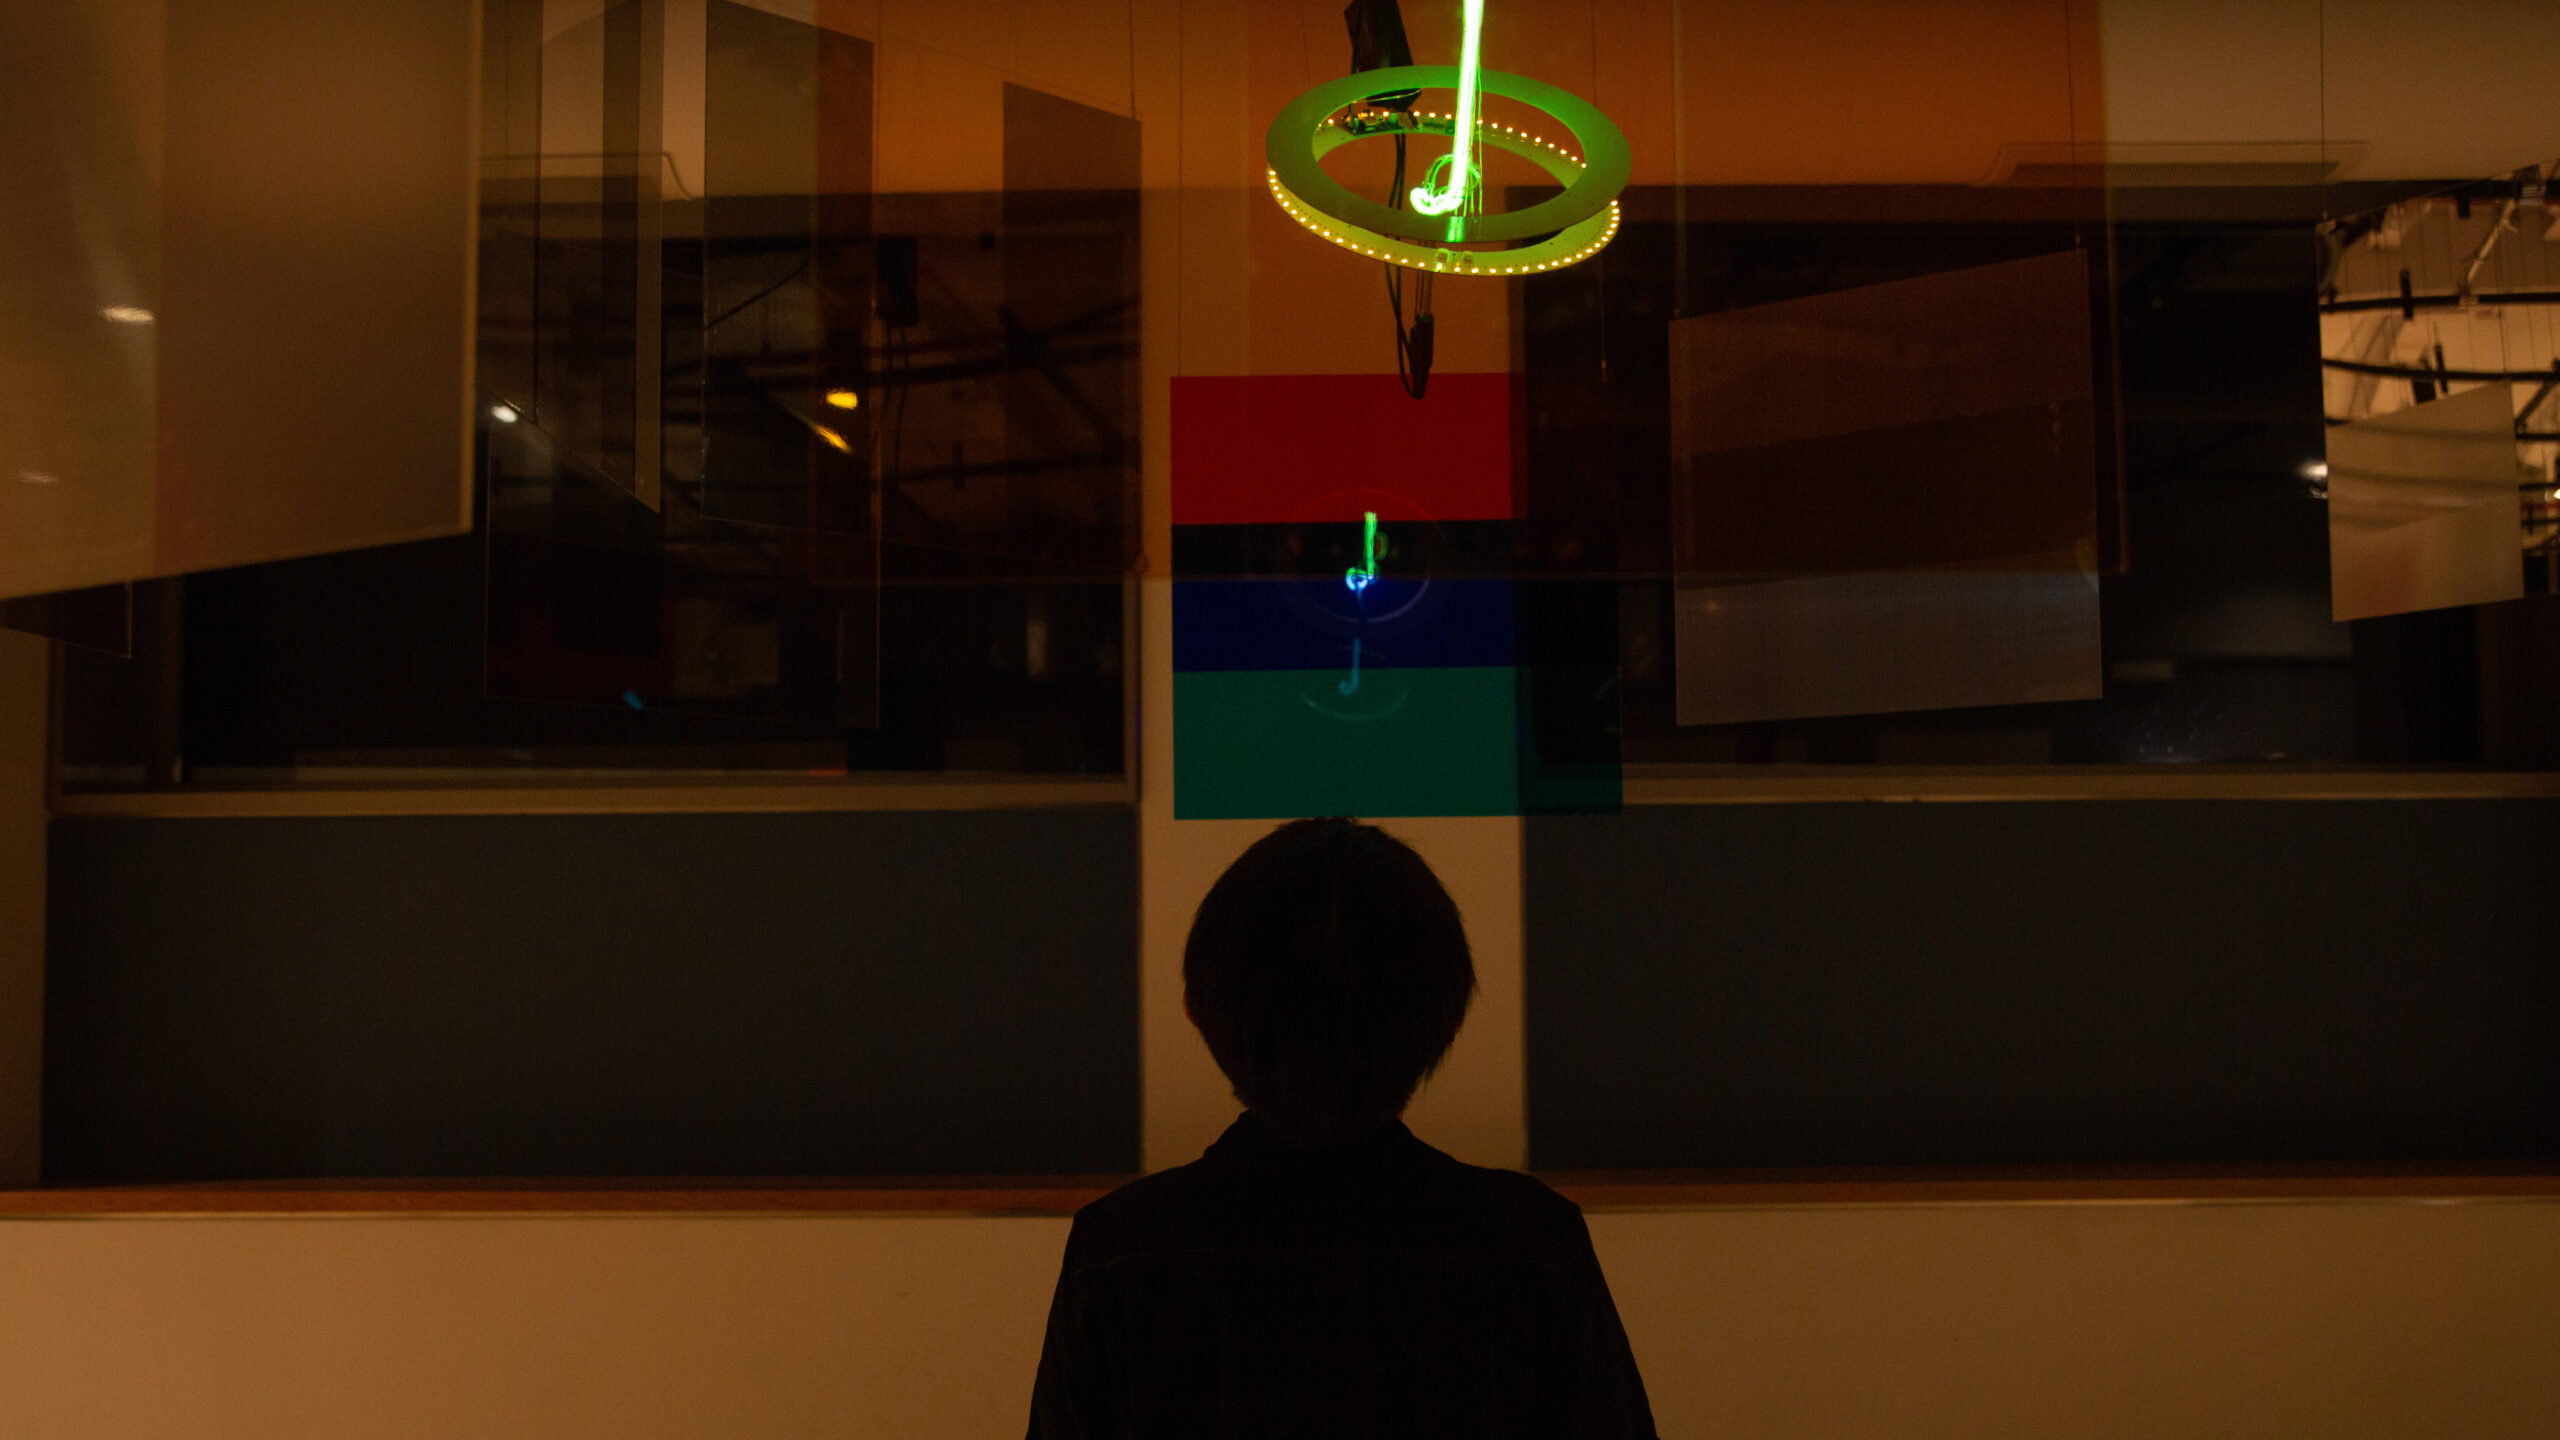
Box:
xmin=1592 ymin=1202 xmax=2560 ymax=1440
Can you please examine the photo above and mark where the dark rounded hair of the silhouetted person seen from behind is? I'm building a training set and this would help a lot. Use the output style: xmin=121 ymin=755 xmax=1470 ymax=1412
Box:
xmin=1183 ymin=820 xmax=1475 ymax=1143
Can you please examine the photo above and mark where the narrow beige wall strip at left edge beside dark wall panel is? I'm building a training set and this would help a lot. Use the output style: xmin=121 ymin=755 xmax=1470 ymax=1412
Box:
xmin=0 ymin=630 xmax=51 ymax=1189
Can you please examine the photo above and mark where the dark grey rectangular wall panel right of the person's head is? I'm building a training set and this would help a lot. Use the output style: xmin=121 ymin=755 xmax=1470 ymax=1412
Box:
xmin=1526 ymin=802 xmax=2560 ymax=1168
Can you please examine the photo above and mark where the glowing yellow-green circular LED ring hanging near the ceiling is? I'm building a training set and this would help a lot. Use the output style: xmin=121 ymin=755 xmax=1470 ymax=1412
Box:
xmin=1262 ymin=64 xmax=1633 ymax=274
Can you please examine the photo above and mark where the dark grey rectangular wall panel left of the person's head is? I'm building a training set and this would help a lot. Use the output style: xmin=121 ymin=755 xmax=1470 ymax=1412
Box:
xmin=44 ymin=810 xmax=1139 ymax=1184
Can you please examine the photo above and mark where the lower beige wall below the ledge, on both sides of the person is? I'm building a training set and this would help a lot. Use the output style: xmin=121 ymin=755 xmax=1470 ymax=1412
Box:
xmin=0 ymin=1202 xmax=2560 ymax=1440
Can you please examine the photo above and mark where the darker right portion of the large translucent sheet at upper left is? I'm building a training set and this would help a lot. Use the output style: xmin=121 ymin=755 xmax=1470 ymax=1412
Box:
xmin=154 ymin=0 xmax=481 ymax=574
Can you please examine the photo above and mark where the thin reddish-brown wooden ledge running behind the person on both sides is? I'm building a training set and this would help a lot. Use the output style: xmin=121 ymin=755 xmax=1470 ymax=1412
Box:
xmin=0 ymin=1163 xmax=2560 ymax=1220
